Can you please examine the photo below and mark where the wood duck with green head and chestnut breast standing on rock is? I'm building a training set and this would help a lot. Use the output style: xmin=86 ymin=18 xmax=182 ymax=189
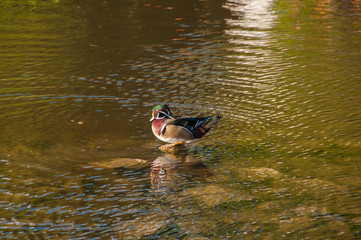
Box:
xmin=150 ymin=104 xmax=220 ymax=144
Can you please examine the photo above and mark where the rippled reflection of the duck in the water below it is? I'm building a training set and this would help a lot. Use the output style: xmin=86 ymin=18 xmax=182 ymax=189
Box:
xmin=151 ymin=153 xmax=211 ymax=192
